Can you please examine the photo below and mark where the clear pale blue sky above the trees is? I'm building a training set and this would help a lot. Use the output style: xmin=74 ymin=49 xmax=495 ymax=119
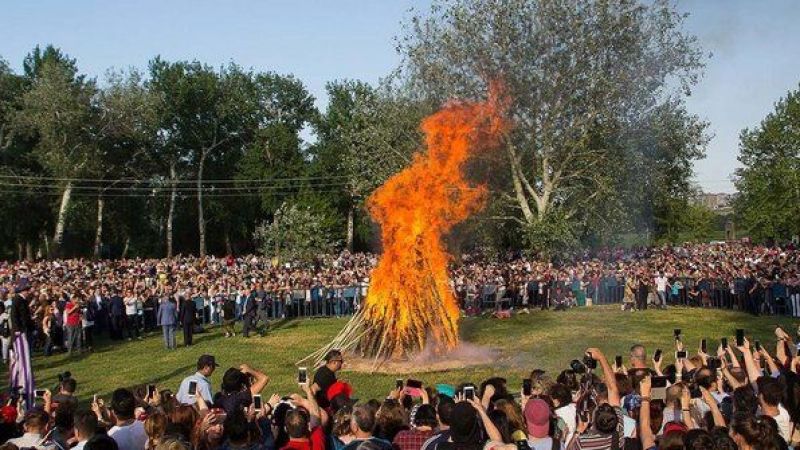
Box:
xmin=0 ymin=0 xmax=800 ymax=192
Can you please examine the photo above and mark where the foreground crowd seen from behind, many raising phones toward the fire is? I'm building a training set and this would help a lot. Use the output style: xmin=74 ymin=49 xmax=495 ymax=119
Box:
xmin=0 ymin=327 xmax=800 ymax=450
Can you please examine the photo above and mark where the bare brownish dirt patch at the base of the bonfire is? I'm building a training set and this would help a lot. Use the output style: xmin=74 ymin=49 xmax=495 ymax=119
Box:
xmin=344 ymin=342 xmax=500 ymax=375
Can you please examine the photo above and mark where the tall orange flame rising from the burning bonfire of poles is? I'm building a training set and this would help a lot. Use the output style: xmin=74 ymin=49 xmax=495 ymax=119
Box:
xmin=359 ymin=85 xmax=507 ymax=358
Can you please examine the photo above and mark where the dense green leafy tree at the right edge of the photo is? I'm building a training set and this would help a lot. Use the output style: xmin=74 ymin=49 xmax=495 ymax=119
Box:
xmin=734 ymin=82 xmax=800 ymax=241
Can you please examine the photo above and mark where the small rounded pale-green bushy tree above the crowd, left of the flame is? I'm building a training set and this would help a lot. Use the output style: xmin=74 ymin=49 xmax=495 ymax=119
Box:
xmin=253 ymin=203 xmax=338 ymax=262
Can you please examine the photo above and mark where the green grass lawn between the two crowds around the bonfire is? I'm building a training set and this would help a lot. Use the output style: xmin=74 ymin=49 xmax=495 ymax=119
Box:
xmin=7 ymin=306 xmax=796 ymax=399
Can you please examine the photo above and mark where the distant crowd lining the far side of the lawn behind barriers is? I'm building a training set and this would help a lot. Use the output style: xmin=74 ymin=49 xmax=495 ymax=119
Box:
xmin=0 ymin=242 xmax=800 ymax=361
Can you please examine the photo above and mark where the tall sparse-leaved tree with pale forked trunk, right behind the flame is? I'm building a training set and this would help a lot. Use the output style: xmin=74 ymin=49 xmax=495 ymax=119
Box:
xmin=399 ymin=0 xmax=702 ymax=253
